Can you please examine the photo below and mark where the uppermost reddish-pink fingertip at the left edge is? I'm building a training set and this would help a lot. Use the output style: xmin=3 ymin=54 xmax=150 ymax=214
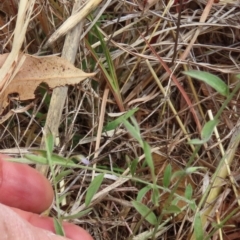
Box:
xmin=0 ymin=155 xmax=53 ymax=213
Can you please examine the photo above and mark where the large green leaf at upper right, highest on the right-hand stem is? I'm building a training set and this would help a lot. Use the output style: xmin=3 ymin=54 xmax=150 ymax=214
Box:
xmin=183 ymin=70 xmax=229 ymax=96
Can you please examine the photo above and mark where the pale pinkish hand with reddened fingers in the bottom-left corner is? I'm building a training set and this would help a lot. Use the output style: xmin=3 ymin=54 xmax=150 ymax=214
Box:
xmin=0 ymin=155 xmax=93 ymax=240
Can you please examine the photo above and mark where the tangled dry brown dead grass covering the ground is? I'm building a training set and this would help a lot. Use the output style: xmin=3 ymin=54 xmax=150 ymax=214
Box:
xmin=0 ymin=0 xmax=240 ymax=240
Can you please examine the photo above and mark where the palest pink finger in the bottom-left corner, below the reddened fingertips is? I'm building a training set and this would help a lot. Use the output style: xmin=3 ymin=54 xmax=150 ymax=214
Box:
xmin=0 ymin=204 xmax=68 ymax=240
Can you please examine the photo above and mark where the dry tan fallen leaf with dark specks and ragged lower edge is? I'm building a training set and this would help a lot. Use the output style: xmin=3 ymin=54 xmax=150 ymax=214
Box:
xmin=0 ymin=54 xmax=95 ymax=114
